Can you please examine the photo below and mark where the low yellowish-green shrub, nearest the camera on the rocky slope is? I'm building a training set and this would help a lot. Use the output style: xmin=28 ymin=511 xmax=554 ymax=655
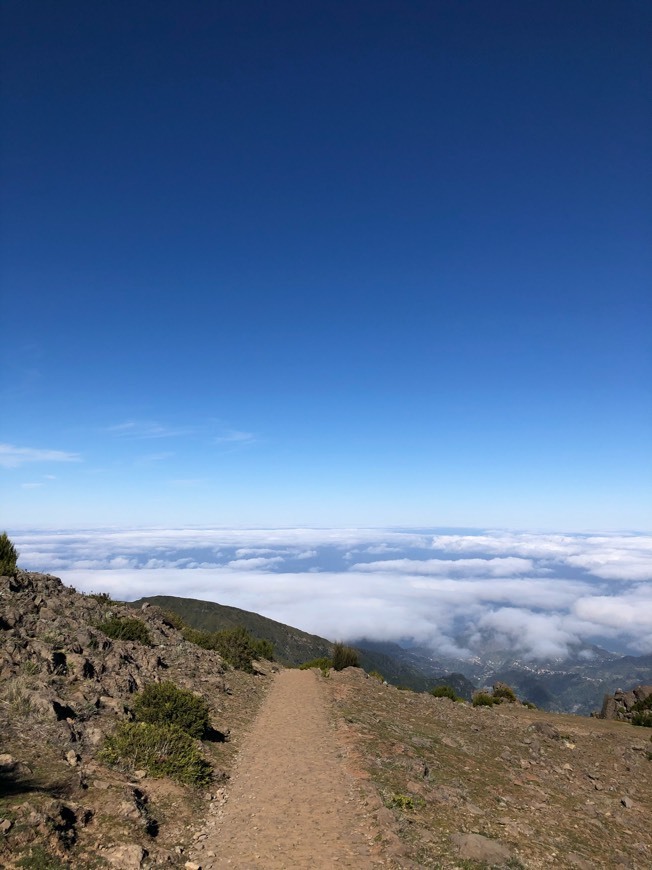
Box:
xmin=100 ymin=722 xmax=212 ymax=786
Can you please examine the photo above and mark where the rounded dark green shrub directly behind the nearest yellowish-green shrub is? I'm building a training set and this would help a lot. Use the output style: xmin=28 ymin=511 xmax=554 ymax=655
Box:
xmin=133 ymin=680 xmax=210 ymax=739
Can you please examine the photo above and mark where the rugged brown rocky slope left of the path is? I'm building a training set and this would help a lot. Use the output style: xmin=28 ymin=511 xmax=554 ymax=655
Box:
xmin=0 ymin=571 xmax=266 ymax=870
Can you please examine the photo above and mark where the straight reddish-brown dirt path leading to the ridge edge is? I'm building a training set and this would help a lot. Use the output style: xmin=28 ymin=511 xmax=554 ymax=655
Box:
xmin=192 ymin=670 xmax=385 ymax=870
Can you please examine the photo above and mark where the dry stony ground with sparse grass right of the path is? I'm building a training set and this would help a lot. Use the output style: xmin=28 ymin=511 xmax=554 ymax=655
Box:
xmin=326 ymin=671 xmax=652 ymax=870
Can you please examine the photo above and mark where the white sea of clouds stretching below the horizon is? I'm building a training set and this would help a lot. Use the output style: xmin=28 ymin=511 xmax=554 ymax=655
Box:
xmin=12 ymin=529 xmax=652 ymax=659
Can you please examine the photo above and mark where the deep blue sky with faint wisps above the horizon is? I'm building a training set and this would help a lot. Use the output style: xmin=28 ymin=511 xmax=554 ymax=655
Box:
xmin=0 ymin=0 xmax=652 ymax=530
